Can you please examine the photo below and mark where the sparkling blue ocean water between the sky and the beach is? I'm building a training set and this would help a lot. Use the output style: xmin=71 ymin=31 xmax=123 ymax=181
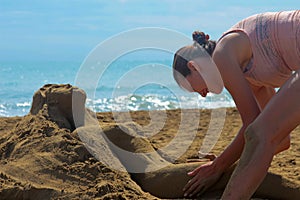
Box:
xmin=0 ymin=59 xmax=234 ymax=116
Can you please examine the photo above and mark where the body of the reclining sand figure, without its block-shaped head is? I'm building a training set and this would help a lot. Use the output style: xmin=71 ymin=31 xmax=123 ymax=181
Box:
xmin=70 ymin=84 xmax=300 ymax=199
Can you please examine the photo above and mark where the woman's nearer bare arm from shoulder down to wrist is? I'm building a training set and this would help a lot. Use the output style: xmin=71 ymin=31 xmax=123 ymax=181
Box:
xmin=213 ymin=32 xmax=260 ymax=170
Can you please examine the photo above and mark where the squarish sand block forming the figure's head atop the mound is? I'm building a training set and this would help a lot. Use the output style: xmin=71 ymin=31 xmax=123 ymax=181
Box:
xmin=30 ymin=84 xmax=86 ymax=131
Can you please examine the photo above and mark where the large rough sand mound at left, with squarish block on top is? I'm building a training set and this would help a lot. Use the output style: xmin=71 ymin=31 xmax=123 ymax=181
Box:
xmin=0 ymin=85 xmax=152 ymax=200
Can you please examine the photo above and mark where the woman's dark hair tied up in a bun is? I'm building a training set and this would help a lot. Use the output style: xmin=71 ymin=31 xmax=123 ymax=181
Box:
xmin=173 ymin=31 xmax=216 ymax=85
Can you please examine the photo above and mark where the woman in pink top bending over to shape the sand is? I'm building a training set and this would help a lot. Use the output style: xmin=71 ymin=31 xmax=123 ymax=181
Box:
xmin=173 ymin=10 xmax=300 ymax=199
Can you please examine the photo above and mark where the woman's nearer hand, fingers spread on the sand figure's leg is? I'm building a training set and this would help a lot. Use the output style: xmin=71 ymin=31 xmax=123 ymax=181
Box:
xmin=183 ymin=161 xmax=223 ymax=197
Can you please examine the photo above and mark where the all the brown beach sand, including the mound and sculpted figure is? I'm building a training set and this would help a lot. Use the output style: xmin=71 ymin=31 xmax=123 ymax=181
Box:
xmin=0 ymin=85 xmax=300 ymax=199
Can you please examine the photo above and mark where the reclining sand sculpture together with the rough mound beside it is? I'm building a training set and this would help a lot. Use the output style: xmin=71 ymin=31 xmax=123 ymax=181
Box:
xmin=0 ymin=84 xmax=300 ymax=199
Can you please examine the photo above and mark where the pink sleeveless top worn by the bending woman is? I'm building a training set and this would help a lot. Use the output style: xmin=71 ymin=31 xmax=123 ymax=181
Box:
xmin=224 ymin=10 xmax=300 ymax=88
